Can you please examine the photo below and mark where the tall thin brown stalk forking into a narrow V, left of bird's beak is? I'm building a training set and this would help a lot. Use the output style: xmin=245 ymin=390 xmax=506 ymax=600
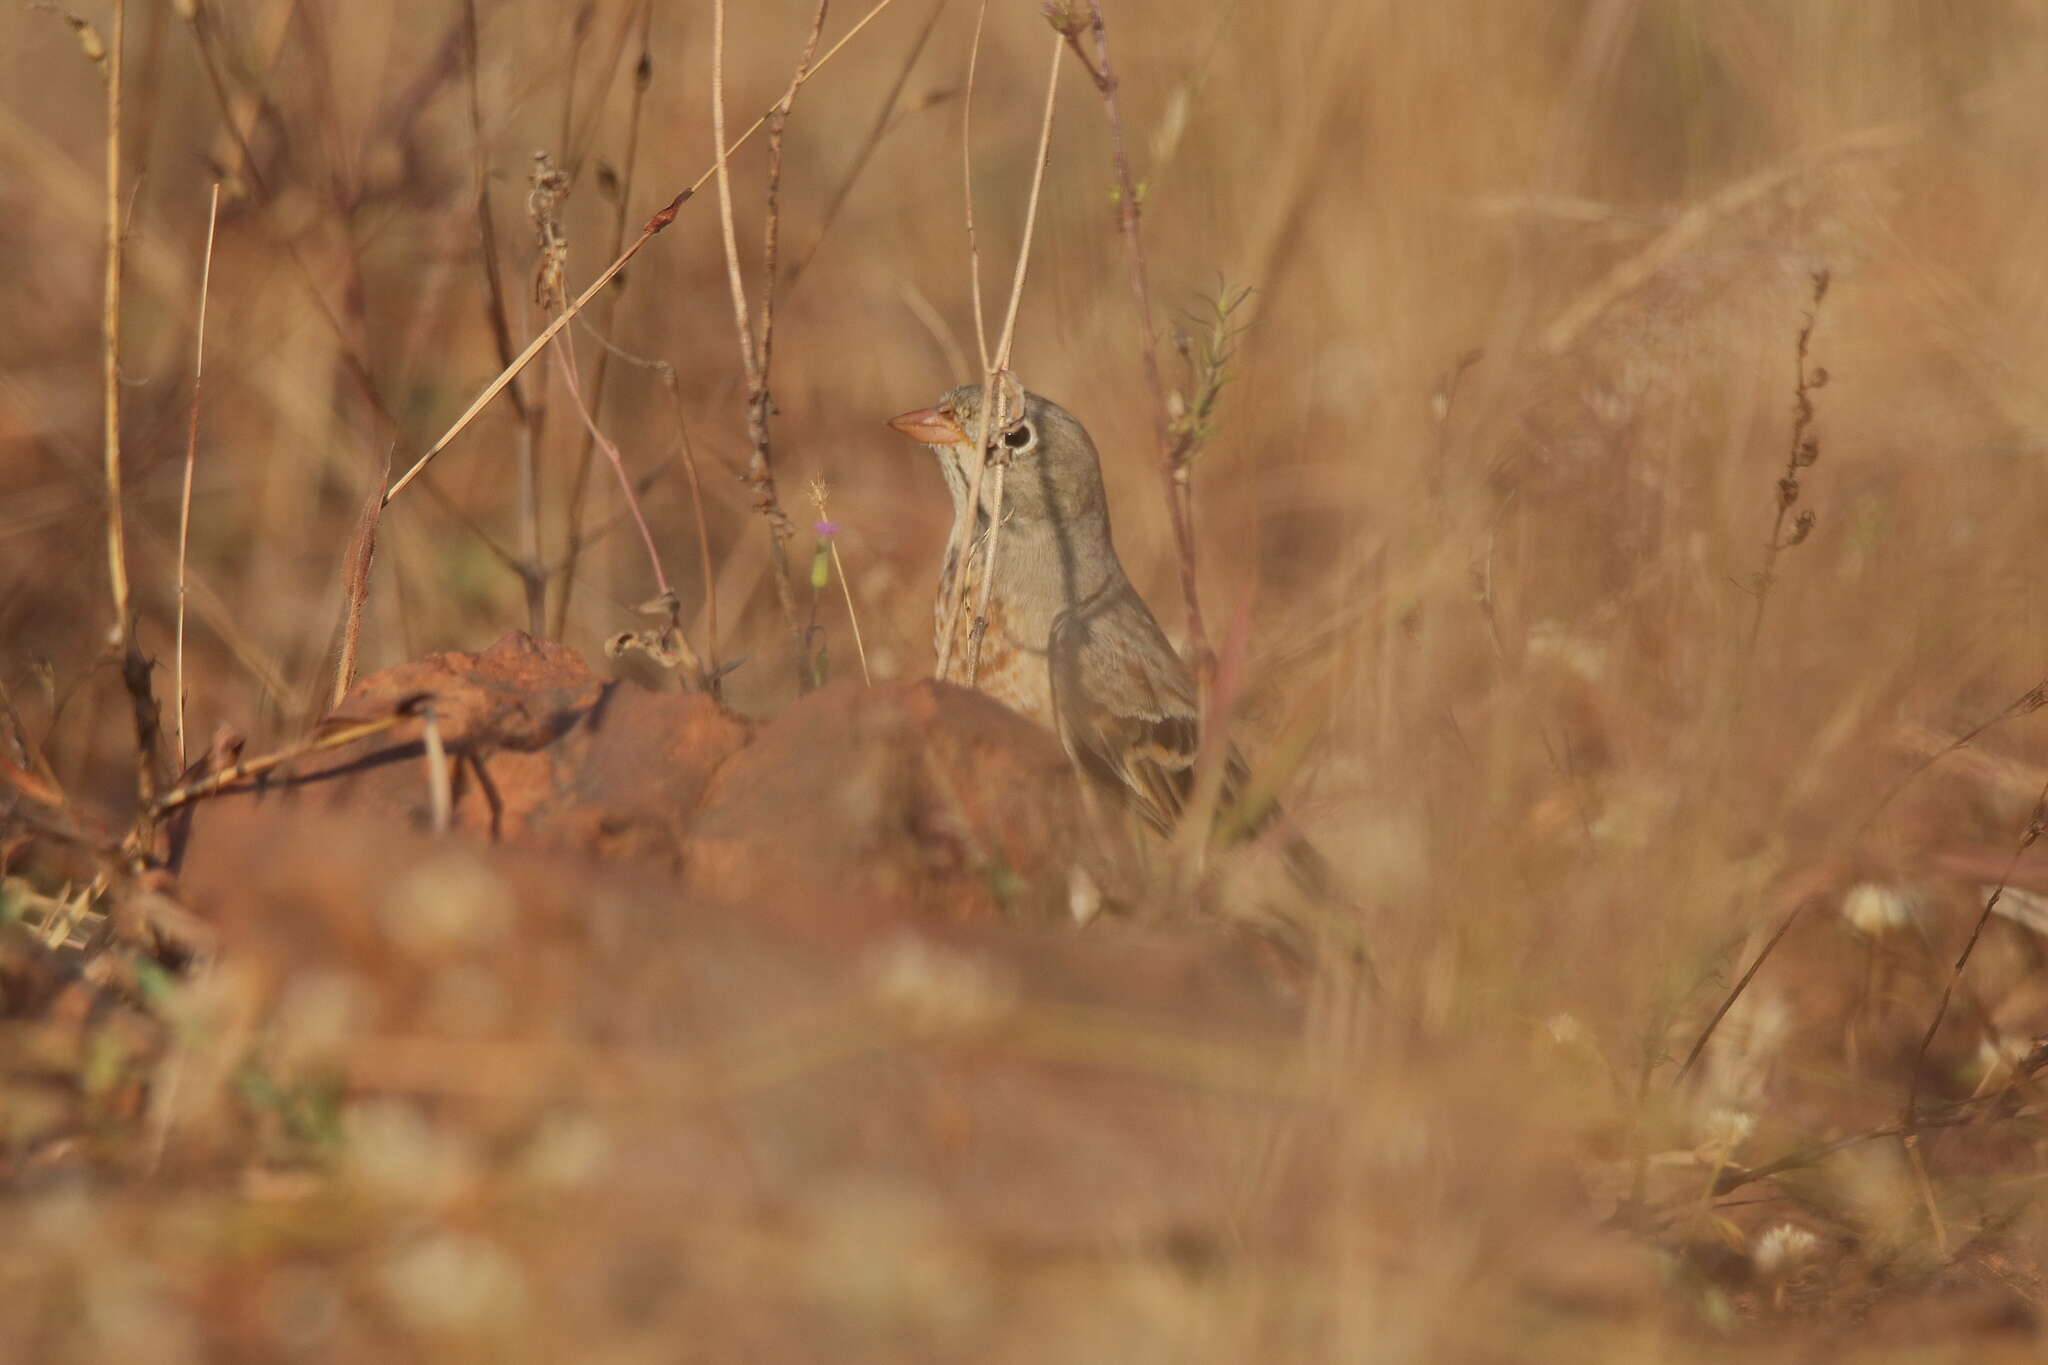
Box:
xmin=711 ymin=0 xmax=829 ymax=690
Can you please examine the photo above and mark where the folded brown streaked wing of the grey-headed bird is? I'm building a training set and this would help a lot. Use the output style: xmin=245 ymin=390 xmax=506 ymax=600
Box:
xmin=1047 ymin=585 xmax=1202 ymax=833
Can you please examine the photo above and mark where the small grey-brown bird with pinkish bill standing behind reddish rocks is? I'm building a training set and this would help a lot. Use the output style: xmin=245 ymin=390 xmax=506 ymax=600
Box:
xmin=889 ymin=381 xmax=1212 ymax=833
